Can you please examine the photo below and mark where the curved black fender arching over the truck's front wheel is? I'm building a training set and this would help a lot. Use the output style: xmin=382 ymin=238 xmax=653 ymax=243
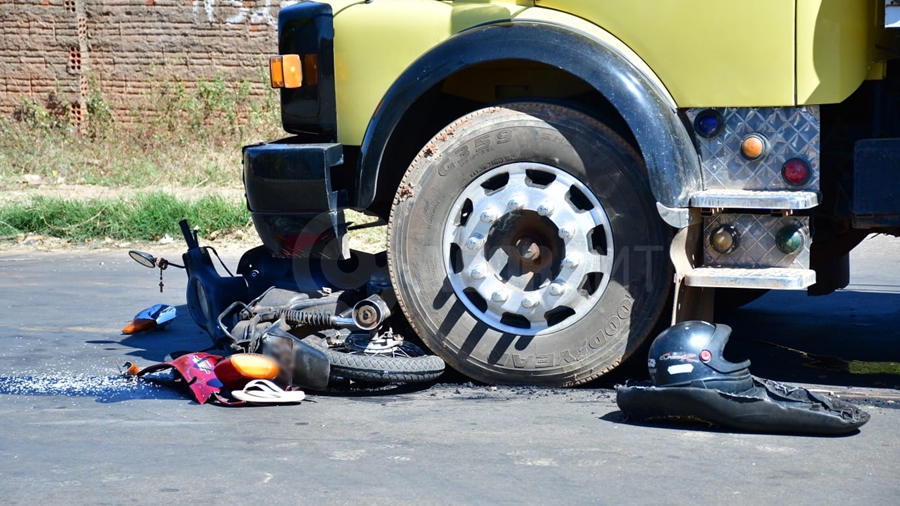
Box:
xmin=356 ymin=21 xmax=702 ymax=208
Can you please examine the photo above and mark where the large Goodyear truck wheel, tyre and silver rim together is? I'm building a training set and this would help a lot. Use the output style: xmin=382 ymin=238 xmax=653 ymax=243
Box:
xmin=388 ymin=102 xmax=672 ymax=386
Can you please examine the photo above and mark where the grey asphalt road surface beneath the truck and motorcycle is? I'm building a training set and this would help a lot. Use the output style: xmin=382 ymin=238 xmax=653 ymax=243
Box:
xmin=0 ymin=238 xmax=900 ymax=505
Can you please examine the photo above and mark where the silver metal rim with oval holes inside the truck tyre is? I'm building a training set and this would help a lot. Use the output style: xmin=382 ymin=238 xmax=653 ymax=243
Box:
xmin=443 ymin=162 xmax=614 ymax=335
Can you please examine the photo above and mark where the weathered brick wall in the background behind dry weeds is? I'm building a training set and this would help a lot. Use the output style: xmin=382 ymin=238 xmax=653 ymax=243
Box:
xmin=0 ymin=0 xmax=284 ymax=128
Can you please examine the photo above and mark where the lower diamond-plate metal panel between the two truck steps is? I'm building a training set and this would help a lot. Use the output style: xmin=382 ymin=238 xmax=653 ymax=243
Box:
xmin=703 ymin=213 xmax=812 ymax=269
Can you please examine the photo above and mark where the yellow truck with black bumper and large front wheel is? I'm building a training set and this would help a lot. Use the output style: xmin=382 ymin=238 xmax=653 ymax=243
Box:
xmin=243 ymin=0 xmax=900 ymax=386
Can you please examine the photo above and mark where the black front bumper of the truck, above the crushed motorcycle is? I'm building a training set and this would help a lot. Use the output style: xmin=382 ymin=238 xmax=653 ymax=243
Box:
xmin=243 ymin=143 xmax=347 ymax=259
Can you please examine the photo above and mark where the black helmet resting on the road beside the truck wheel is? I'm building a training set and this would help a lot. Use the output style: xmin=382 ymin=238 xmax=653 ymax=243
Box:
xmin=647 ymin=321 xmax=753 ymax=393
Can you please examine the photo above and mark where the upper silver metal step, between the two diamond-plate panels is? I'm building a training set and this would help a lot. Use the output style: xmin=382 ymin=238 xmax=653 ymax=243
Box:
xmin=691 ymin=190 xmax=819 ymax=209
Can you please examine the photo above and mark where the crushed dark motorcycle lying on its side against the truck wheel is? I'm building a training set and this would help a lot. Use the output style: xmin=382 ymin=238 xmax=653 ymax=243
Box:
xmin=128 ymin=220 xmax=444 ymax=390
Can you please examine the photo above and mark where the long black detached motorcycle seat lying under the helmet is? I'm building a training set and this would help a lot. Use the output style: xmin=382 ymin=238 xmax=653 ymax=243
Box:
xmin=616 ymin=376 xmax=869 ymax=435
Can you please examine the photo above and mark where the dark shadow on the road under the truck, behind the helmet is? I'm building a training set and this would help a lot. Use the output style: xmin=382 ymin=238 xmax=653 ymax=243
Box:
xmin=718 ymin=291 xmax=900 ymax=388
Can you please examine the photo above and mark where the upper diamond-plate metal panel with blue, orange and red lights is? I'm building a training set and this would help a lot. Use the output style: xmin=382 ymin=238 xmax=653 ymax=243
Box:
xmin=687 ymin=106 xmax=820 ymax=190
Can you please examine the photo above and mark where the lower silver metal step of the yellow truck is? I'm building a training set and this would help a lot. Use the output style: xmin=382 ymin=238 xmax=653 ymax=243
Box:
xmin=684 ymin=267 xmax=816 ymax=290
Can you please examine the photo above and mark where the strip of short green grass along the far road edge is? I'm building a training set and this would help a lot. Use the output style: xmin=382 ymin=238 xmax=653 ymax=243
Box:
xmin=0 ymin=192 xmax=250 ymax=241
